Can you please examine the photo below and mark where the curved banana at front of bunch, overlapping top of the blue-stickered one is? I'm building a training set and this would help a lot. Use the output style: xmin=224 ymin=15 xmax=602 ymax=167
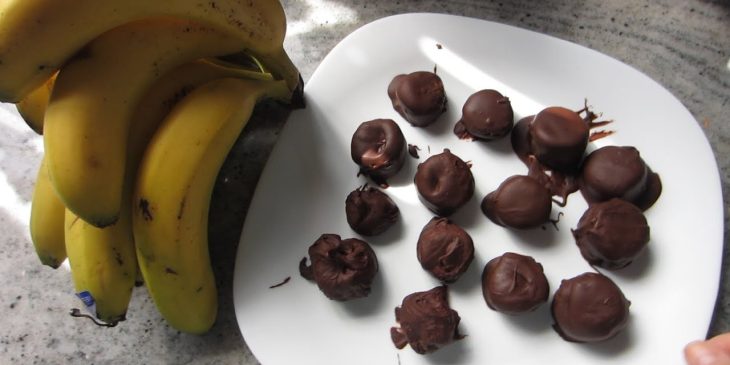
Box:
xmin=43 ymin=18 xmax=253 ymax=227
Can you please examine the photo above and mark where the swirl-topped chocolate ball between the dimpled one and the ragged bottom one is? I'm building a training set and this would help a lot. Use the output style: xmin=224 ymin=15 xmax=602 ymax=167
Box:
xmin=416 ymin=217 xmax=474 ymax=283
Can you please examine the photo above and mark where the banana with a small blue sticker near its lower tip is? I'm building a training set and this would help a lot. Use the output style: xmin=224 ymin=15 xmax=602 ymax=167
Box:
xmin=65 ymin=203 xmax=137 ymax=325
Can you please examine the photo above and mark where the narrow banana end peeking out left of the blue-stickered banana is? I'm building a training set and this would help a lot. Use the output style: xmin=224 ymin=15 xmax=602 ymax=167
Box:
xmin=30 ymin=154 xmax=66 ymax=269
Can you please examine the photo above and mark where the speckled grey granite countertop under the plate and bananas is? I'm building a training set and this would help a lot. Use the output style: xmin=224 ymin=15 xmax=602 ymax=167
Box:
xmin=0 ymin=0 xmax=730 ymax=364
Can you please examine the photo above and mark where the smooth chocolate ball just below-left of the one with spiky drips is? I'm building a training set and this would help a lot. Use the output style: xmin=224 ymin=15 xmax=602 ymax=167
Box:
xmin=481 ymin=175 xmax=552 ymax=229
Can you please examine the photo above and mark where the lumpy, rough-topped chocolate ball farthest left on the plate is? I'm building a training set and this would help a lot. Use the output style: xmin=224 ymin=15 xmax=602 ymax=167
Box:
xmin=299 ymin=234 xmax=378 ymax=301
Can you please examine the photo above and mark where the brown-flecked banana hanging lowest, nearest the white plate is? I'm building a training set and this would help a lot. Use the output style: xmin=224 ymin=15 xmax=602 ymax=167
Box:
xmin=132 ymin=79 xmax=291 ymax=333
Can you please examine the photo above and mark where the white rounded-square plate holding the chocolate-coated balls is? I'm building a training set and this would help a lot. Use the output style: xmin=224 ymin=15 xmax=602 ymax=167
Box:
xmin=234 ymin=14 xmax=723 ymax=365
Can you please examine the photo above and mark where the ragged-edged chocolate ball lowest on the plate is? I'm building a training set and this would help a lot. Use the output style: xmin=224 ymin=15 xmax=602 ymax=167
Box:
xmin=390 ymin=285 xmax=463 ymax=354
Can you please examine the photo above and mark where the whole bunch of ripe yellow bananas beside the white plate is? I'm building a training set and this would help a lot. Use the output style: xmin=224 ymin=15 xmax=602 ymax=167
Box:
xmin=0 ymin=0 xmax=302 ymax=333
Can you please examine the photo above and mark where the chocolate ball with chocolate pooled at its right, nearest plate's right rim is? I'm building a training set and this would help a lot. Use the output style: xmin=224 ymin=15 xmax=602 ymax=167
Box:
xmin=580 ymin=146 xmax=661 ymax=209
